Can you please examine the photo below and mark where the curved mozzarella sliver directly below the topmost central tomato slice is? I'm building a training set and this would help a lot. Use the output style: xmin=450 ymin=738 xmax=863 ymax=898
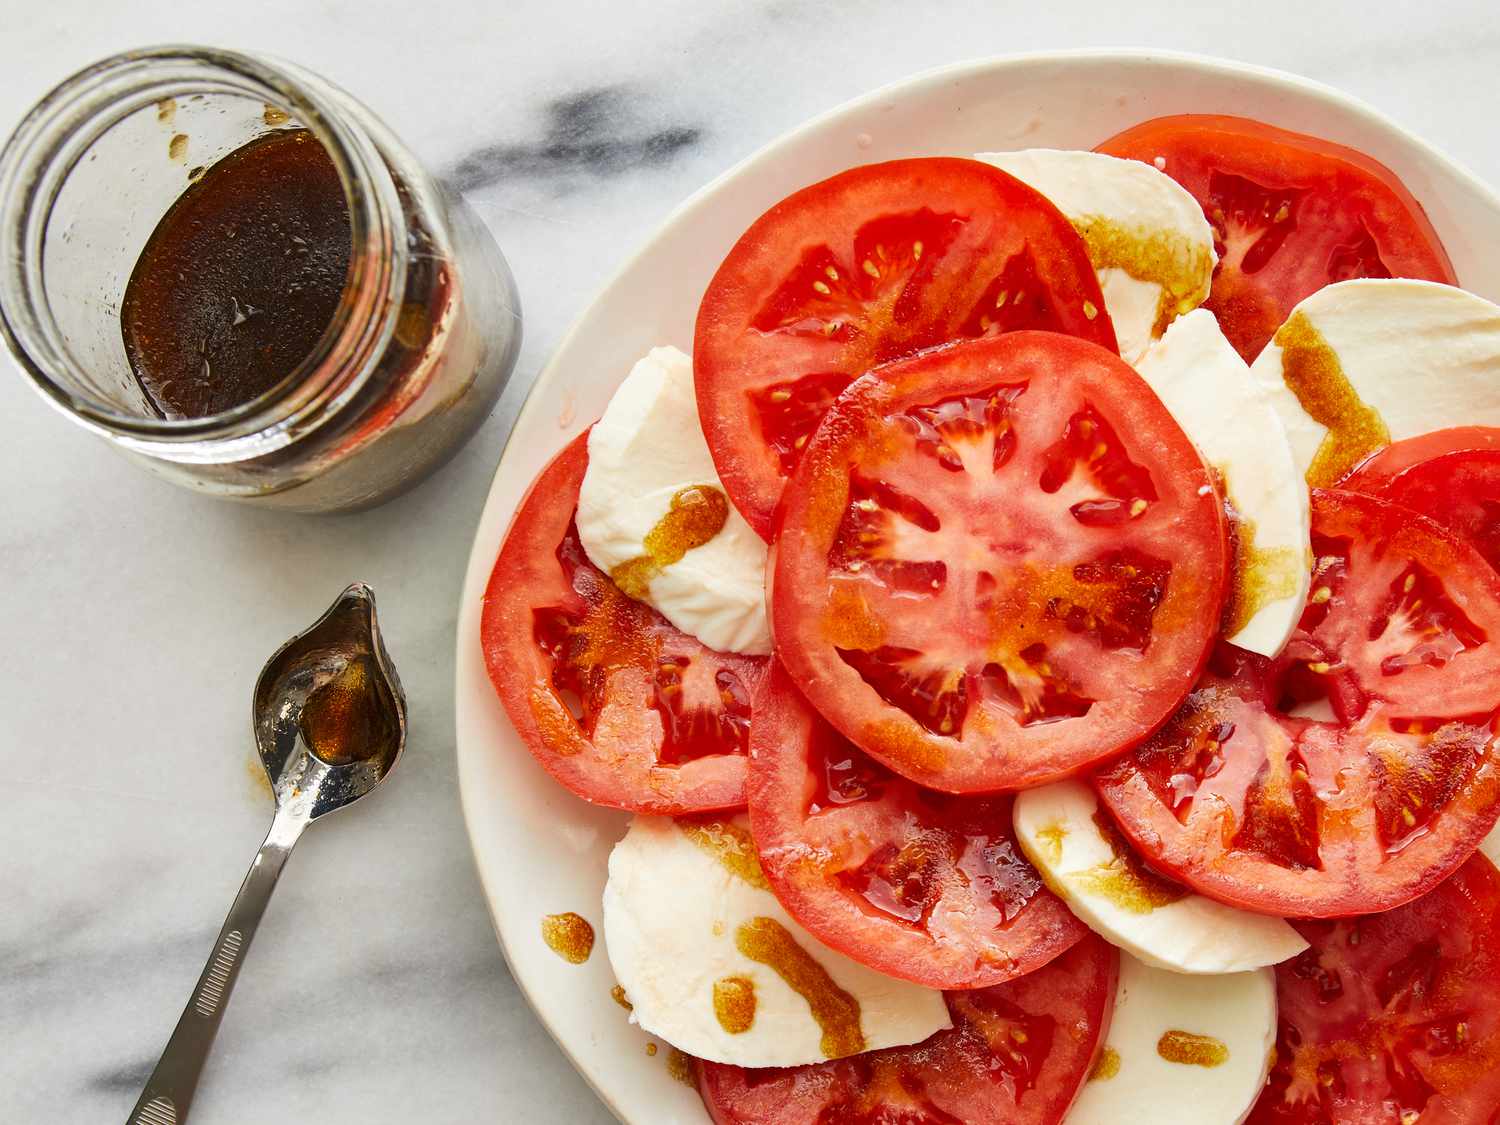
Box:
xmin=1014 ymin=782 xmax=1308 ymax=974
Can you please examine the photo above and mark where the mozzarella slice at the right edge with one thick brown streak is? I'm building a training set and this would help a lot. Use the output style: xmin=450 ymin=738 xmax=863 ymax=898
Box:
xmin=1251 ymin=278 xmax=1500 ymax=488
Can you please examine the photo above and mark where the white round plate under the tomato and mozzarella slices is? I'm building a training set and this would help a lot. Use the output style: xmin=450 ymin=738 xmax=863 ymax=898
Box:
xmin=456 ymin=51 xmax=1500 ymax=1125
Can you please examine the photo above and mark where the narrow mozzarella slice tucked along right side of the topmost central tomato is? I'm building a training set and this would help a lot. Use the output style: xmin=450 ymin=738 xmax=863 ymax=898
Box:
xmin=1136 ymin=309 xmax=1313 ymax=657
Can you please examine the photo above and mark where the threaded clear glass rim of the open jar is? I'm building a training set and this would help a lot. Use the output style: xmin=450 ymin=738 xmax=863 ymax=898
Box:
xmin=0 ymin=45 xmax=407 ymax=450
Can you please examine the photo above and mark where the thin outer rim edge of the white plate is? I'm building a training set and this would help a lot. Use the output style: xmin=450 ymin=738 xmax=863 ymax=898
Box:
xmin=453 ymin=47 xmax=1500 ymax=1125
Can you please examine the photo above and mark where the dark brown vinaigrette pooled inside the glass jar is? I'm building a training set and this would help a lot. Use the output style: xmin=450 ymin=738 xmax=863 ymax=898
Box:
xmin=120 ymin=129 xmax=353 ymax=419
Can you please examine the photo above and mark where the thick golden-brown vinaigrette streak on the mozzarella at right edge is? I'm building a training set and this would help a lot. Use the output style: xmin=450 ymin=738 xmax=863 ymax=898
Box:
xmin=1274 ymin=312 xmax=1391 ymax=488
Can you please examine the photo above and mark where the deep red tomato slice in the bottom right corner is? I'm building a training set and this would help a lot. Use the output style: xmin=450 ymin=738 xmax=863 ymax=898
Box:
xmin=1250 ymin=855 xmax=1500 ymax=1125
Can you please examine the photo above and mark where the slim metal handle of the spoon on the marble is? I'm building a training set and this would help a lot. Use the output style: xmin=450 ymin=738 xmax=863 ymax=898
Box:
xmin=128 ymin=812 xmax=308 ymax=1125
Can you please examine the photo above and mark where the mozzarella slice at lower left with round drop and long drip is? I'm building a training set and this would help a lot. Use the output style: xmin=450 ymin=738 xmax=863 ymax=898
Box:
xmin=605 ymin=816 xmax=953 ymax=1067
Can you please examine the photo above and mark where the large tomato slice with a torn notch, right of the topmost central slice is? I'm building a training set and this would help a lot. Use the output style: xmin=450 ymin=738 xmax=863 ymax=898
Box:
xmin=1095 ymin=489 xmax=1500 ymax=918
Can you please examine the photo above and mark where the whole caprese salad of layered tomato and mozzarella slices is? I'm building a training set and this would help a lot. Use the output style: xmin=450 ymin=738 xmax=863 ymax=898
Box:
xmin=482 ymin=116 xmax=1500 ymax=1125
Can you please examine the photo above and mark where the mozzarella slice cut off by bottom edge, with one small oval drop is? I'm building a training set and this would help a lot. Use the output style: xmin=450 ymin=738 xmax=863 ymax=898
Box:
xmin=1065 ymin=954 xmax=1277 ymax=1125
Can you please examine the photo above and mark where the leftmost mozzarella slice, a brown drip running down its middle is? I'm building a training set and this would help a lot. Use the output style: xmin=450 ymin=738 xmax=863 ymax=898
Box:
xmin=578 ymin=348 xmax=771 ymax=654
